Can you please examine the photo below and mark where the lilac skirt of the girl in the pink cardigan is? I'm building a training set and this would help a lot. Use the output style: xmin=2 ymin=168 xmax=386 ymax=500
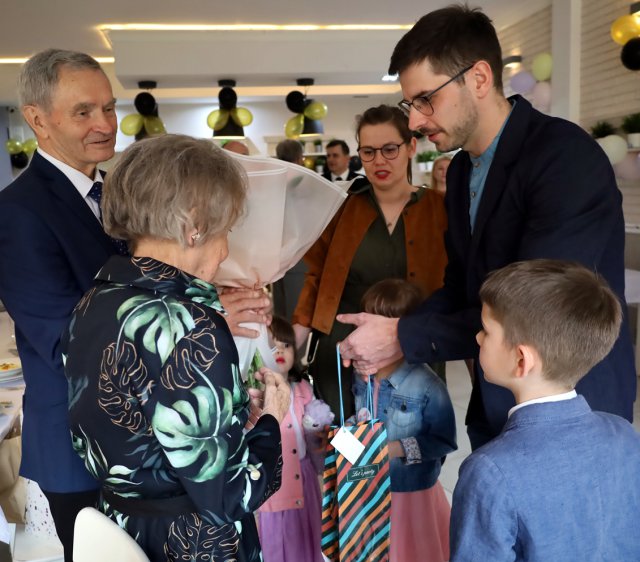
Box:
xmin=258 ymin=457 xmax=323 ymax=562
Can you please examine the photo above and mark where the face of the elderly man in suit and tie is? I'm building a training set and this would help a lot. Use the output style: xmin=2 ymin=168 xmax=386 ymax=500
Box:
xmin=25 ymin=67 xmax=118 ymax=177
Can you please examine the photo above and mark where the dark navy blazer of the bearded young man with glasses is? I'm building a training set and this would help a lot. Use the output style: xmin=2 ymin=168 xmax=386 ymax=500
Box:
xmin=398 ymin=96 xmax=636 ymax=435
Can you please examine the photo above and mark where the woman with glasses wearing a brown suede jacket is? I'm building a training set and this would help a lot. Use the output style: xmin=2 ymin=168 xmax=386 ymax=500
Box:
xmin=293 ymin=105 xmax=447 ymax=415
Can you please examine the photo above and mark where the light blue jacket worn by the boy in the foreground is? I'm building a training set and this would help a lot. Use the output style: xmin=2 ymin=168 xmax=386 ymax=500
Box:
xmin=451 ymin=396 xmax=640 ymax=562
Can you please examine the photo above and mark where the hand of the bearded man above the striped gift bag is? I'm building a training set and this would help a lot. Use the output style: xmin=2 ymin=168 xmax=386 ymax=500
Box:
xmin=336 ymin=312 xmax=402 ymax=375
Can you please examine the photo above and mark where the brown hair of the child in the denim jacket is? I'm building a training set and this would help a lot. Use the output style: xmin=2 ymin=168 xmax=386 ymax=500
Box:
xmin=362 ymin=279 xmax=424 ymax=318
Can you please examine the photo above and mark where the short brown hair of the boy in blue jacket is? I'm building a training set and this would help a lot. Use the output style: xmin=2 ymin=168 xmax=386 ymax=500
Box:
xmin=480 ymin=259 xmax=622 ymax=388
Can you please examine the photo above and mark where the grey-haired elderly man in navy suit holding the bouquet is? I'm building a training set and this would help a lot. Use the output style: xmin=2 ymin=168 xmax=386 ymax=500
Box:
xmin=0 ymin=49 xmax=269 ymax=562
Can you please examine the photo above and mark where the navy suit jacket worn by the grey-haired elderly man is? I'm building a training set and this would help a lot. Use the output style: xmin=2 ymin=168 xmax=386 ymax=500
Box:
xmin=0 ymin=152 xmax=115 ymax=493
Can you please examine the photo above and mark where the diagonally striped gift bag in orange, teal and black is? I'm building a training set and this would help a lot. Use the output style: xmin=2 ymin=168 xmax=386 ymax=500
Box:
xmin=322 ymin=348 xmax=391 ymax=562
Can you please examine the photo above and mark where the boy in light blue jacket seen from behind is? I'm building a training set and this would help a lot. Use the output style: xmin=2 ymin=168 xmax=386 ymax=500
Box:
xmin=451 ymin=260 xmax=640 ymax=562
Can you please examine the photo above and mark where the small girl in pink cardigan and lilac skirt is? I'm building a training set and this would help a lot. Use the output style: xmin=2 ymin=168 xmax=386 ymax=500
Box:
xmin=258 ymin=316 xmax=323 ymax=562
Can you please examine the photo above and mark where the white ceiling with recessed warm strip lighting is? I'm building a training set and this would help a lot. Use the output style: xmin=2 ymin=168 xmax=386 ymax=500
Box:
xmin=0 ymin=0 xmax=551 ymax=105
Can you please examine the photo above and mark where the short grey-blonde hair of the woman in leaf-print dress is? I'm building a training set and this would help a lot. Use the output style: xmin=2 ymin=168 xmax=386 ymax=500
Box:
xmin=102 ymin=135 xmax=247 ymax=247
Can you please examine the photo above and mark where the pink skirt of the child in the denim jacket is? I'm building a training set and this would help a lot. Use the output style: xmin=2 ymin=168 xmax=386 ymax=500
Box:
xmin=390 ymin=476 xmax=451 ymax=562
